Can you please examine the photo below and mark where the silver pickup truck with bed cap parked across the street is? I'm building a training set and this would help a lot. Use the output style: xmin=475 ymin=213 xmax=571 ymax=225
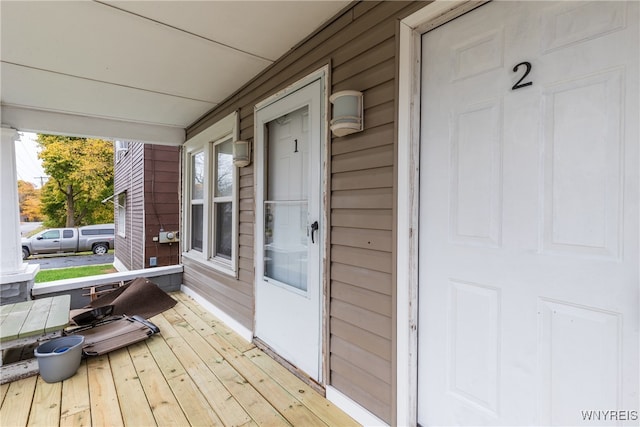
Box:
xmin=22 ymin=224 xmax=115 ymax=259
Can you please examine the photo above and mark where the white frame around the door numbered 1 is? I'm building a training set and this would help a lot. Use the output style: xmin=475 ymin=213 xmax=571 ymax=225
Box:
xmin=253 ymin=64 xmax=331 ymax=385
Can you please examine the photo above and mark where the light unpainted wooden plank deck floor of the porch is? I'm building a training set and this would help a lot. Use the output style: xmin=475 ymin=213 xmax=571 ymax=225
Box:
xmin=0 ymin=292 xmax=357 ymax=427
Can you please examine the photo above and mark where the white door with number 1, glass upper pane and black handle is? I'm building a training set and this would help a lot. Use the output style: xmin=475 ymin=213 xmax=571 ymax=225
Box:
xmin=255 ymin=80 xmax=323 ymax=381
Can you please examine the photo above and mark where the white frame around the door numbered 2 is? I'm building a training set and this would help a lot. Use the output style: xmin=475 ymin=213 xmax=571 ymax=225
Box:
xmin=396 ymin=0 xmax=488 ymax=426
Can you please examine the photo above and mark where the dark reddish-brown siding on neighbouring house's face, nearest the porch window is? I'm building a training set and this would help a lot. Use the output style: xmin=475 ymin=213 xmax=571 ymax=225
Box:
xmin=144 ymin=144 xmax=180 ymax=268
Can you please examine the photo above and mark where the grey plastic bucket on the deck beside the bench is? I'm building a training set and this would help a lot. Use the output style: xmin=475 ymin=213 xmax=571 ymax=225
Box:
xmin=33 ymin=335 xmax=84 ymax=383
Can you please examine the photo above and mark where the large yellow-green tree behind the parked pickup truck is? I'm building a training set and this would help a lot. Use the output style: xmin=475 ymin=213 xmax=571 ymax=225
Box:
xmin=38 ymin=134 xmax=113 ymax=227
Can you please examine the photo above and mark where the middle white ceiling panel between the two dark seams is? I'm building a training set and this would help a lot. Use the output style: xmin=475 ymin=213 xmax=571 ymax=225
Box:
xmin=2 ymin=2 xmax=271 ymax=102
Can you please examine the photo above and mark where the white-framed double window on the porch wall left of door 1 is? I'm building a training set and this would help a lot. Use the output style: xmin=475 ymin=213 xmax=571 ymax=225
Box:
xmin=183 ymin=113 xmax=238 ymax=274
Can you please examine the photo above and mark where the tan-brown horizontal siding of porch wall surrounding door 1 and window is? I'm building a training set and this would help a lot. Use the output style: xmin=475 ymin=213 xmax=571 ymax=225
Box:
xmin=184 ymin=2 xmax=424 ymax=422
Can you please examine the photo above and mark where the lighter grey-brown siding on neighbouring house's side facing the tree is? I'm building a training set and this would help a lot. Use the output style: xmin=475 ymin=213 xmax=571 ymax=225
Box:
xmin=114 ymin=142 xmax=144 ymax=270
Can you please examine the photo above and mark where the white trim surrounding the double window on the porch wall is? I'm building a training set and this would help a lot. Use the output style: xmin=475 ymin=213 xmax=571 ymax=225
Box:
xmin=181 ymin=112 xmax=240 ymax=277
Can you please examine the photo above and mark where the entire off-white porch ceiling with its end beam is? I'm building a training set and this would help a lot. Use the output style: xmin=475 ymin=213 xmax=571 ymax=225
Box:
xmin=0 ymin=0 xmax=349 ymax=144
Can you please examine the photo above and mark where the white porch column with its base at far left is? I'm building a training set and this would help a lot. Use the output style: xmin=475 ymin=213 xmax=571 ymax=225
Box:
xmin=0 ymin=126 xmax=40 ymax=304
